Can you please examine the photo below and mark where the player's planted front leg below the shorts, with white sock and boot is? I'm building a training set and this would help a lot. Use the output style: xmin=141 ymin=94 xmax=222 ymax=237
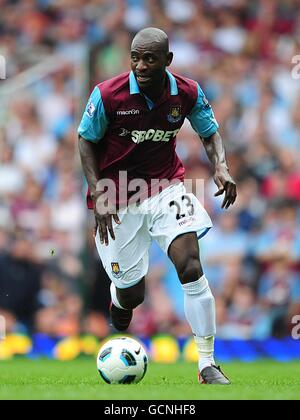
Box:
xmin=168 ymin=232 xmax=229 ymax=385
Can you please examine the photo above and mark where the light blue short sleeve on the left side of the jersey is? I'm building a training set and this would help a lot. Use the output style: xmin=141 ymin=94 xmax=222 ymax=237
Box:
xmin=78 ymin=87 xmax=108 ymax=143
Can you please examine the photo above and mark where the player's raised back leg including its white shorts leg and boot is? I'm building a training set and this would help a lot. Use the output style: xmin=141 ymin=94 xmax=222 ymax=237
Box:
xmin=95 ymin=211 xmax=151 ymax=331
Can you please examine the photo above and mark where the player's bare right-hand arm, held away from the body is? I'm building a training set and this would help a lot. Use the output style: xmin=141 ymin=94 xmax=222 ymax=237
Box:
xmin=200 ymin=131 xmax=237 ymax=209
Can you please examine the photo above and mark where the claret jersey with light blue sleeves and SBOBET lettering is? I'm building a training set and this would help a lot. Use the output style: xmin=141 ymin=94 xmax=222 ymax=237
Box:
xmin=78 ymin=71 xmax=218 ymax=207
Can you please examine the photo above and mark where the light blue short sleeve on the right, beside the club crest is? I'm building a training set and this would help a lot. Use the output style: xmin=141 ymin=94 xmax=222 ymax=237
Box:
xmin=187 ymin=84 xmax=219 ymax=138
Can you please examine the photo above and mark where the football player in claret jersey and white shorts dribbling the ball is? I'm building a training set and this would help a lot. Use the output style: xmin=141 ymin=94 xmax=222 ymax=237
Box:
xmin=78 ymin=28 xmax=237 ymax=384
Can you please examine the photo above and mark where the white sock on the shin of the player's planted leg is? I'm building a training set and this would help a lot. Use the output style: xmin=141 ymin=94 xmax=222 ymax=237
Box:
xmin=182 ymin=275 xmax=216 ymax=372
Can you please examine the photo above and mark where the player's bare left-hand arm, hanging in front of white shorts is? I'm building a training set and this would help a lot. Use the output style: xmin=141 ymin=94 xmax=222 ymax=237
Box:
xmin=78 ymin=136 xmax=121 ymax=245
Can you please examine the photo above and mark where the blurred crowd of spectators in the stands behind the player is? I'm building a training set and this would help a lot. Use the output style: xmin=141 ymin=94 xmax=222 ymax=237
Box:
xmin=0 ymin=0 xmax=300 ymax=339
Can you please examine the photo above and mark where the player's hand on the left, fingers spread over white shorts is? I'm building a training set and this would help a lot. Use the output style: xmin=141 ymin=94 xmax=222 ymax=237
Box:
xmin=93 ymin=194 xmax=121 ymax=246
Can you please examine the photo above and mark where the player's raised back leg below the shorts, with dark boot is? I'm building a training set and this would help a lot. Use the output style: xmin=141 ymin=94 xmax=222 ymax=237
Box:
xmin=110 ymin=277 xmax=145 ymax=331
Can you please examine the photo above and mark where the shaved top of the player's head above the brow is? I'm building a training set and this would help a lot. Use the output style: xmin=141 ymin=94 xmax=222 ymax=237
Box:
xmin=131 ymin=28 xmax=169 ymax=54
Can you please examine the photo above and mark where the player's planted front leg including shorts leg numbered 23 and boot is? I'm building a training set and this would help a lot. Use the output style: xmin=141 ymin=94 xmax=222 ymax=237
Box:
xmin=150 ymin=184 xmax=229 ymax=384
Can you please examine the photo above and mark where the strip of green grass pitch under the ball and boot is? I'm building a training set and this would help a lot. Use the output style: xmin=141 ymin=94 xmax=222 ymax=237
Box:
xmin=0 ymin=358 xmax=300 ymax=400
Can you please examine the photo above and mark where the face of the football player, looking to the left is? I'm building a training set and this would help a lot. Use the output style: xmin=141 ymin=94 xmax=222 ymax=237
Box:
xmin=131 ymin=44 xmax=173 ymax=90
